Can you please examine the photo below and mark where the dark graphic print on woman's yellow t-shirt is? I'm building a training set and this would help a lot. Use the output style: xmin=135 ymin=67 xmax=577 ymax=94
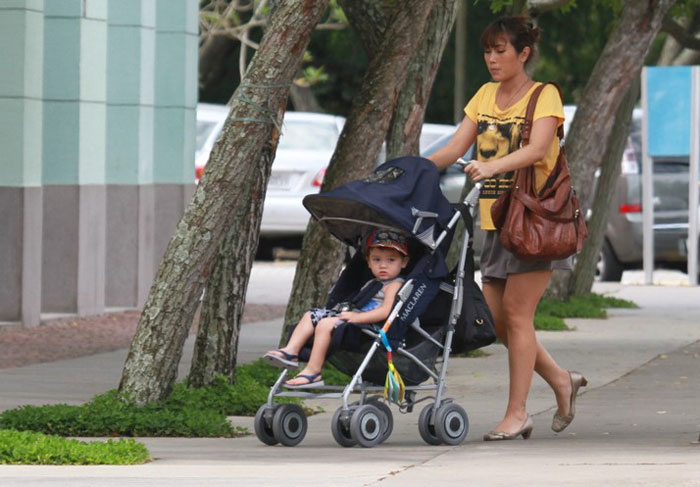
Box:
xmin=476 ymin=114 xmax=524 ymax=230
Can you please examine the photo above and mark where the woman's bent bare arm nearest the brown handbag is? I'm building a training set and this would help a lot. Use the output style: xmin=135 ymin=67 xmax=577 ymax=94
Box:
xmin=464 ymin=117 xmax=559 ymax=181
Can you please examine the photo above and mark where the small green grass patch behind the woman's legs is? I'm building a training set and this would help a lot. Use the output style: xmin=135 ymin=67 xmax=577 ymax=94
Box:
xmin=535 ymin=293 xmax=637 ymax=331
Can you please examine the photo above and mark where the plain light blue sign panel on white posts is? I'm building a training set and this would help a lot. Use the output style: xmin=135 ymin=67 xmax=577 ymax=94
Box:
xmin=646 ymin=66 xmax=691 ymax=157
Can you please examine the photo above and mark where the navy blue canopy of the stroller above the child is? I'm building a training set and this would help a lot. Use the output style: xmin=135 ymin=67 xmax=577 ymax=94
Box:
xmin=304 ymin=157 xmax=454 ymax=246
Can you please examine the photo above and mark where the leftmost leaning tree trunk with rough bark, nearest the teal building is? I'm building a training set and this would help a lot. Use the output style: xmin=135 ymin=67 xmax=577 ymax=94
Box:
xmin=119 ymin=0 xmax=328 ymax=406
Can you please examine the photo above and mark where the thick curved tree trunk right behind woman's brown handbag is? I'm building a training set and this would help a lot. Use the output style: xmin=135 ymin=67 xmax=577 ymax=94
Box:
xmin=547 ymin=0 xmax=675 ymax=298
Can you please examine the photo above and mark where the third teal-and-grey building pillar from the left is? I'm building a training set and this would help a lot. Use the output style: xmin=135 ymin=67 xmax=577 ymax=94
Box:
xmin=105 ymin=0 xmax=156 ymax=308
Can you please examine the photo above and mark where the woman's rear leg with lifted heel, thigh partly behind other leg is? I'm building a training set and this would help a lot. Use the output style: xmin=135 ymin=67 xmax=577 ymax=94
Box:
xmin=483 ymin=274 xmax=571 ymax=424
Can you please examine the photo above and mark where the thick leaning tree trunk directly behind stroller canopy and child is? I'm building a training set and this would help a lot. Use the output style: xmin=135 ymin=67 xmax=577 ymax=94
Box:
xmin=281 ymin=0 xmax=435 ymax=343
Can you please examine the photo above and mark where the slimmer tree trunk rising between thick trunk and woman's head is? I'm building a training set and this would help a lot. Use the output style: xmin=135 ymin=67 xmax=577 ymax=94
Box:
xmin=386 ymin=0 xmax=459 ymax=159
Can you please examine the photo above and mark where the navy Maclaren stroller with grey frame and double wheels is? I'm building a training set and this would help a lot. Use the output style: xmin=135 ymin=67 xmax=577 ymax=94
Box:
xmin=254 ymin=157 xmax=495 ymax=447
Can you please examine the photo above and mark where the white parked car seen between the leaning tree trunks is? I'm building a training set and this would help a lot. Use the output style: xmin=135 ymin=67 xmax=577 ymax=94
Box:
xmin=195 ymin=103 xmax=345 ymax=237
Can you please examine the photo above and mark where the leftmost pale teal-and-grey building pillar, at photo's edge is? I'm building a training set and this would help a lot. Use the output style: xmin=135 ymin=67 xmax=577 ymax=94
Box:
xmin=0 ymin=0 xmax=44 ymax=326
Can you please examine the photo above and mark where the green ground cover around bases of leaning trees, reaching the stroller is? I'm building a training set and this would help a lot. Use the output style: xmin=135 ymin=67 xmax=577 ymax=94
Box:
xmin=0 ymin=360 xmax=349 ymax=437
